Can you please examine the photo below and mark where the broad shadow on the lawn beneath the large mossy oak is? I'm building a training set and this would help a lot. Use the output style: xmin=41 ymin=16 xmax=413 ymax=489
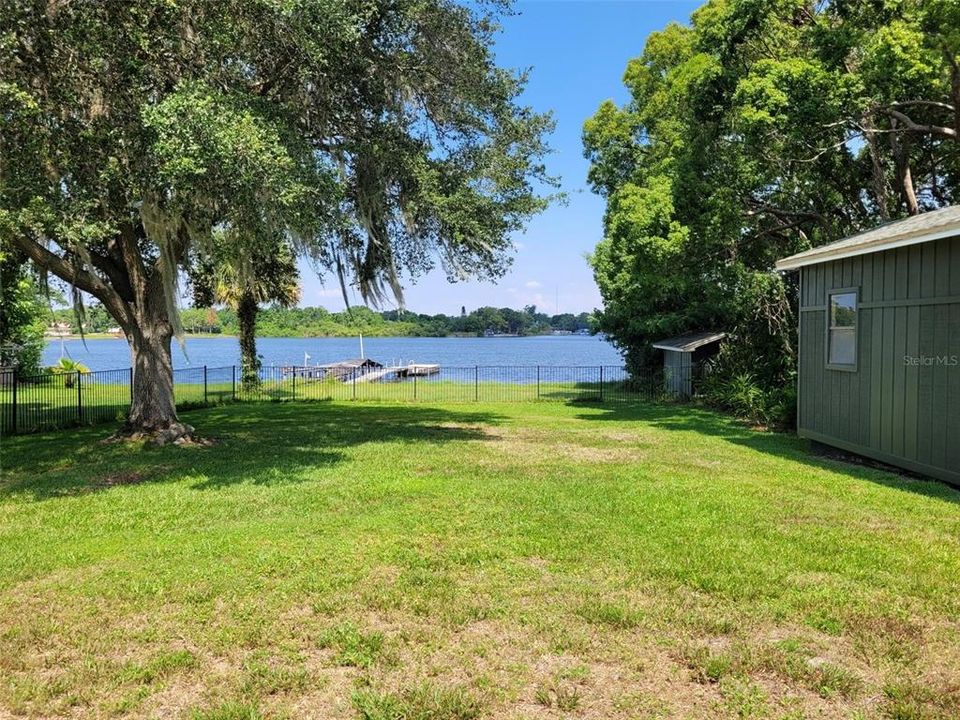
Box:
xmin=0 ymin=402 xmax=500 ymax=500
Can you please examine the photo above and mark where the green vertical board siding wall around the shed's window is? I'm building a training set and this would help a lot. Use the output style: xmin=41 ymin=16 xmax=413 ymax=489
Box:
xmin=799 ymin=238 xmax=960 ymax=484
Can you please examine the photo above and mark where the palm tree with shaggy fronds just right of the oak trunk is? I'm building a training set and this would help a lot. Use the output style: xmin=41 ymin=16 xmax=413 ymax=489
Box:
xmin=191 ymin=233 xmax=300 ymax=390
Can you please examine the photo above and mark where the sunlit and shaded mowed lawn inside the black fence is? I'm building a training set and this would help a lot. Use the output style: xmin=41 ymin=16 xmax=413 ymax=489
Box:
xmin=0 ymin=403 xmax=960 ymax=720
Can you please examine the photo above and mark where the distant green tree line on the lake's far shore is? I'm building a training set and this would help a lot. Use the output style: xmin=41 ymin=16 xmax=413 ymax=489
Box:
xmin=53 ymin=305 xmax=594 ymax=337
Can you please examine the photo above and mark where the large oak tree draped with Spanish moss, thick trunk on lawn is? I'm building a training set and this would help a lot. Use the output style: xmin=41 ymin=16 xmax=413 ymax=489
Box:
xmin=0 ymin=0 xmax=550 ymax=442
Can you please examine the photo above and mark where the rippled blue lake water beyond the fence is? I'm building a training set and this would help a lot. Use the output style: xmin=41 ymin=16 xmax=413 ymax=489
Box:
xmin=43 ymin=335 xmax=623 ymax=370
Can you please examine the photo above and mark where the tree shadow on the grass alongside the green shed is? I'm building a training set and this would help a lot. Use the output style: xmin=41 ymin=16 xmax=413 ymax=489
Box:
xmin=577 ymin=403 xmax=960 ymax=504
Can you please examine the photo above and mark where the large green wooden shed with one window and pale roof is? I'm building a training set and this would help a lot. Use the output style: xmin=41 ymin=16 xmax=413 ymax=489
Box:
xmin=777 ymin=206 xmax=960 ymax=484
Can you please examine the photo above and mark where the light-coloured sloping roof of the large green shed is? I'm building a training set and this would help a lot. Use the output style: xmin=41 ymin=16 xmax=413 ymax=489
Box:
xmin=777 ymin=205 xmax=960 ymax=270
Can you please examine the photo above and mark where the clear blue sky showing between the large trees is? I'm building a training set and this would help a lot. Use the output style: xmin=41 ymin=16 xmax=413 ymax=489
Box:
xmin=301 ymin=0 xmax=700 ymax=314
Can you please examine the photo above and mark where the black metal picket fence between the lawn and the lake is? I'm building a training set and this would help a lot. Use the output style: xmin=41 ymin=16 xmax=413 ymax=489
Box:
xmin=0 ymin=365 xmax=698 ymax=435
